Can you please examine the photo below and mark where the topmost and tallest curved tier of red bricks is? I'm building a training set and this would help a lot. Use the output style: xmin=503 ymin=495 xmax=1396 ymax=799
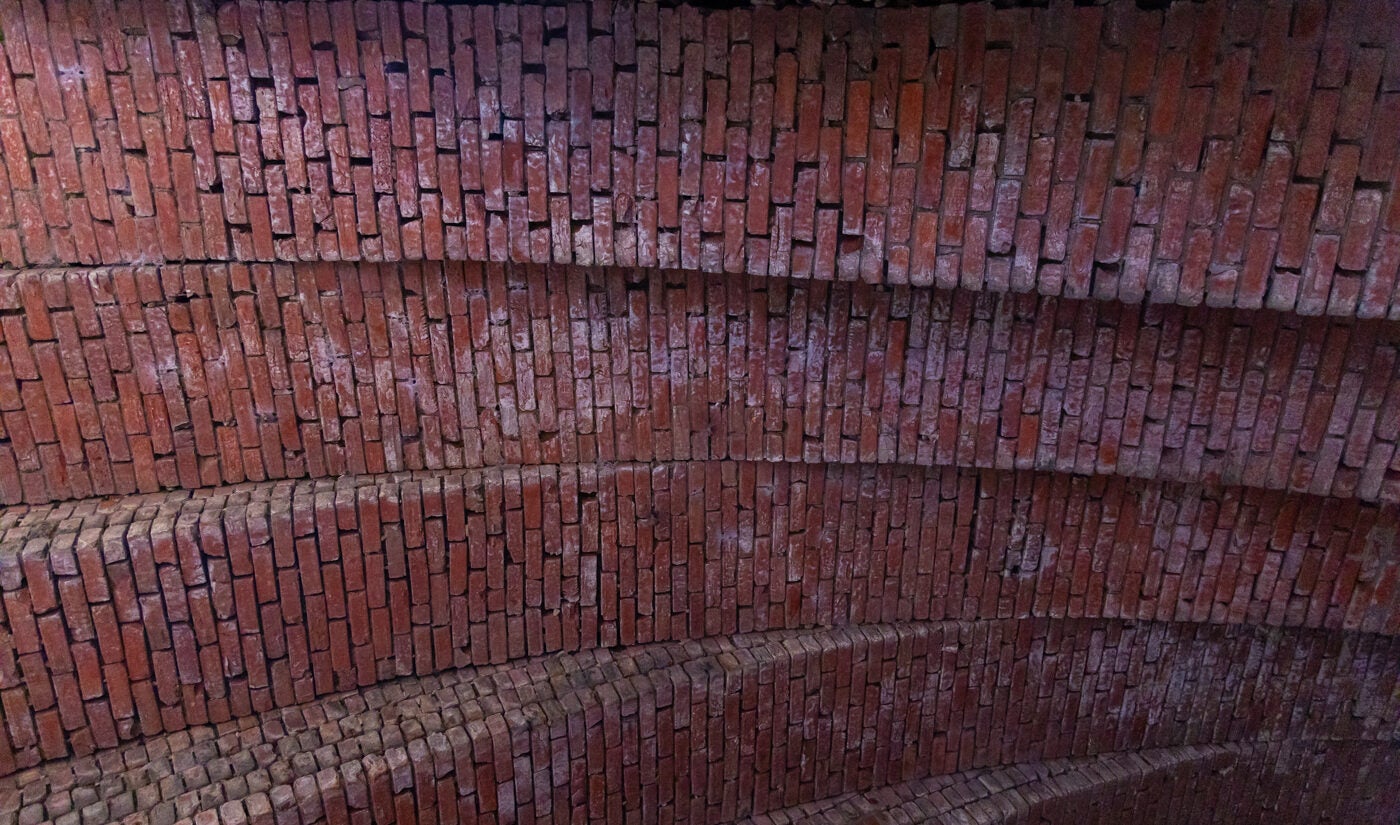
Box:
xmin=0 ymin=0 xmax=1400 ymax=318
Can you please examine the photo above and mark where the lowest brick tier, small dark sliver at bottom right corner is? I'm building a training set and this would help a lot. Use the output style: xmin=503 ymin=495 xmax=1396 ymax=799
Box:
xmin=752 ymin=742 xmax=1400 ymax=825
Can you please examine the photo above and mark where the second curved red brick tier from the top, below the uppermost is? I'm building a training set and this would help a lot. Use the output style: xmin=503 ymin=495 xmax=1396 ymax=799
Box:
xmin=0 ymin=262 xmax=1400 ymax=503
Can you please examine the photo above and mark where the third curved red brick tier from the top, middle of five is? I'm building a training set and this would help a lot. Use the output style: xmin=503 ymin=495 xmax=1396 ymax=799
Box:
xmin=0 ymin=462 xmax=1400 ymax=772
